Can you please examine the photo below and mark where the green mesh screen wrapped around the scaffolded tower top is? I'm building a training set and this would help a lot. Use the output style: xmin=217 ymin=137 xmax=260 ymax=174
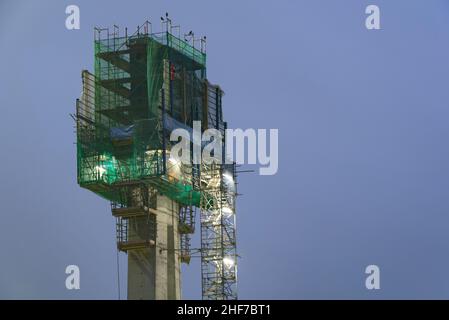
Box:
xmin=77 ymin=33 xmax=206 ymax=205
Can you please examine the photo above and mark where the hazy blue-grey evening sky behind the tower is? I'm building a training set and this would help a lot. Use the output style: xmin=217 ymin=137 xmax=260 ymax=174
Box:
xmin=0 ymin=0 xmax=449 ymax=299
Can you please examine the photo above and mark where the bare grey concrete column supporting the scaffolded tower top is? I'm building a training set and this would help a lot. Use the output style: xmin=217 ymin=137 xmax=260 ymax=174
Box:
xmin=128 ymin=195 xmax=181 ymax=300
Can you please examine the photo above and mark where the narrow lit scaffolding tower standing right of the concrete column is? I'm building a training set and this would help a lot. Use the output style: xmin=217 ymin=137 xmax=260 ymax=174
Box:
xmin=201 ymin=163 xmax=237 ymax=300
